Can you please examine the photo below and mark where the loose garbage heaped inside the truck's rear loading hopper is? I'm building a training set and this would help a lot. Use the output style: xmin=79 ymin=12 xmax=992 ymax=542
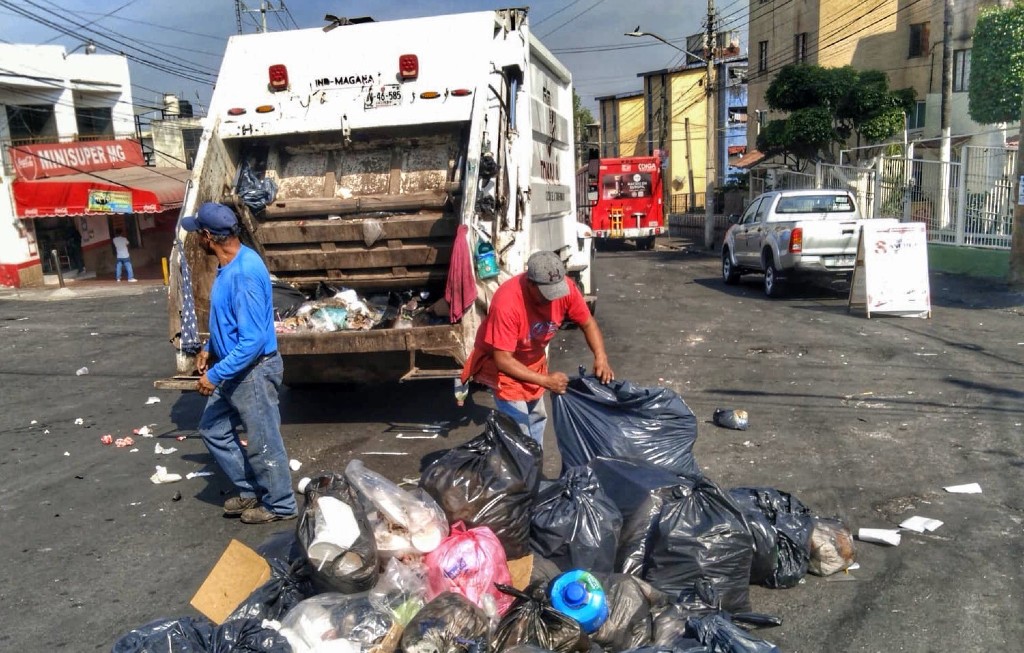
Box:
xmin=273 ymin=280 xmax=447 ymax=334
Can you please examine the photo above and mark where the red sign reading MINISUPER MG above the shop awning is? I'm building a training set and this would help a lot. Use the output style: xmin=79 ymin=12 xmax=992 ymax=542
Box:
xmin=9 ymin=140 xmax=145 ymax=181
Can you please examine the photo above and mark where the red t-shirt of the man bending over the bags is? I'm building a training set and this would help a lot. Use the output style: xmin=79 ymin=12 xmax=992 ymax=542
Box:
xmin=463 ymin=273 xmax=590 ymax=401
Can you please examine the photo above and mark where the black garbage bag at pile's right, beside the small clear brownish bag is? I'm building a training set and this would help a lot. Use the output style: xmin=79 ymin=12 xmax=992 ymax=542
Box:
xmin=729 ymin=487 xmax=813 ymax=589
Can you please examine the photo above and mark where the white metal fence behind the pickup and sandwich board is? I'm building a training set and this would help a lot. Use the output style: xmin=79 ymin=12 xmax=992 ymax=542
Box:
xmin=751 ymin=145 xmax=1017 ymax=249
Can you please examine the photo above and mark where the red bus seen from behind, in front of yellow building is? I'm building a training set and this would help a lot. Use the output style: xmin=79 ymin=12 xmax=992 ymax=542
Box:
xmin=577 ymin=157 xmax=665 ymax=250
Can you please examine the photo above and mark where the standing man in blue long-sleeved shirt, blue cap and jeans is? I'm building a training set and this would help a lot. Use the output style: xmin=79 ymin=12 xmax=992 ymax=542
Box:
xmin=181 ymin=202 xmax=296 ymax=524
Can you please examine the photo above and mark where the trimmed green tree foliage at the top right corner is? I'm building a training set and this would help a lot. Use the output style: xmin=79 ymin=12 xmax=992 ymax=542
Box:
xmin=968 ymin=0 xmax=1024 ymax=125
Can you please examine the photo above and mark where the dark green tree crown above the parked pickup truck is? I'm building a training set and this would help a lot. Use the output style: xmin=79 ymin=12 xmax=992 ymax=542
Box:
xmin=758 ymin=63 xmax=915 ymax=170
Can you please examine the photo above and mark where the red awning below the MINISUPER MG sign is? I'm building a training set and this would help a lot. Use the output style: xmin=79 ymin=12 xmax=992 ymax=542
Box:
xmin=13 ymin=167 xmax=191 ymax=218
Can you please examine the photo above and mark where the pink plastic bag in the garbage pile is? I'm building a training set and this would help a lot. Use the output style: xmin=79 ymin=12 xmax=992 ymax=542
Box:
xmin=423 ymin=522 xmax=513 ymax=614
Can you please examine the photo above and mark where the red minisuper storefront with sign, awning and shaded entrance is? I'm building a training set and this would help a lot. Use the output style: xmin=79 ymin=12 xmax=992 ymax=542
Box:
xmin=0 ymin=140 xmax=191 ymax=287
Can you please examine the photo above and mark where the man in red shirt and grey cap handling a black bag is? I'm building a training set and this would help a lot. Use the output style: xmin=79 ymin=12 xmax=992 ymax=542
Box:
xmin=462 ymin=252 xmax=615 ymax=445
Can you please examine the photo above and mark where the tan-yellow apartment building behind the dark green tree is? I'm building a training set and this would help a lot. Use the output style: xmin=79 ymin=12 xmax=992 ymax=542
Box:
xmin=748 ymin=0 xmax=1001 ymax=157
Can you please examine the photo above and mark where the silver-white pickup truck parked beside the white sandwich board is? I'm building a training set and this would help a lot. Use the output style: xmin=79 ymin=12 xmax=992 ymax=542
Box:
xmin=722 ymin=189 xmax=898 ymax=297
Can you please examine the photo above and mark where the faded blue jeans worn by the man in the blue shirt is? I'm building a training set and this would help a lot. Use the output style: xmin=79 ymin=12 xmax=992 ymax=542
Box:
xmin=199 ymin=355 xmax=297 ymax=515
